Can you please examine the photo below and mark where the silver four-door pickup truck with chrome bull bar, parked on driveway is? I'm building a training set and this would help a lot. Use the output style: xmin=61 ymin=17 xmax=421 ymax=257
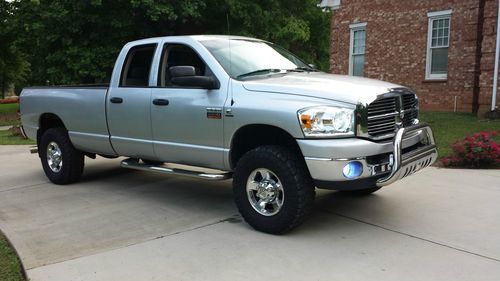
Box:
xmin=21 ymin=35 xmax=437 ymax=234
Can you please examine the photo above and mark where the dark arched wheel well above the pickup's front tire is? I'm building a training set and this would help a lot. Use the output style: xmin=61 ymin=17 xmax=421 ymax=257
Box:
xmin=229 ymin=124 xmax=302 ymax=169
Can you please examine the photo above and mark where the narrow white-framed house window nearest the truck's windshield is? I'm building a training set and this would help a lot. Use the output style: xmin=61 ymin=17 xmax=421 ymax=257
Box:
xmin=349 ymin=22 xmax=366 ymax=76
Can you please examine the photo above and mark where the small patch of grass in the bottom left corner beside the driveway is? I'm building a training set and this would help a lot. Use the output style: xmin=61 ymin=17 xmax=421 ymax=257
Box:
xmin=0 ymin=233 xmax=25 ymax=281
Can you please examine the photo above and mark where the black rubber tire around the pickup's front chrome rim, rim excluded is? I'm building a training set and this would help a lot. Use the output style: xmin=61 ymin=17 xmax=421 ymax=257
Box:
xmin=233 ymin=145 xmax=315 ymax=234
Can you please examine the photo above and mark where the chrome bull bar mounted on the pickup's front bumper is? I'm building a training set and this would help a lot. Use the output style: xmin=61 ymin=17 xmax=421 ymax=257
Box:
xmin=377 ymin=123 xmax=438 ymax=187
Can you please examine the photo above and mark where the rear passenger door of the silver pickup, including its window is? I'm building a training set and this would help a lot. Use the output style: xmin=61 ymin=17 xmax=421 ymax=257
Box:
xmin=107 ymin=44 xmax=156 ymax=159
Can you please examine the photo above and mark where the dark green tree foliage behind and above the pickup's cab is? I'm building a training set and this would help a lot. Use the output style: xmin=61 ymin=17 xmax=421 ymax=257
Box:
xmin=4 ymin=0 xmax=330 ymax=85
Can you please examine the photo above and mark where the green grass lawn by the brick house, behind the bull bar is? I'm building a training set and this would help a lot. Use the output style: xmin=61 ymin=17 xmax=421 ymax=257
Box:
xmin=420 ymin=112 xmax=500 ymax=158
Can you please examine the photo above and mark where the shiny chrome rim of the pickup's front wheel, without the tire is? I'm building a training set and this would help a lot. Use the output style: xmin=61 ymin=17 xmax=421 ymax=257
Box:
xmin=246 ymin=168 xmax=285 ymax=216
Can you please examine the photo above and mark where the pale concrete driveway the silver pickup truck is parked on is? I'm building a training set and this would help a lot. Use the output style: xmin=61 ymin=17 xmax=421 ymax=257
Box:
xmin=0 ymin=146 xmax=500 ymax=281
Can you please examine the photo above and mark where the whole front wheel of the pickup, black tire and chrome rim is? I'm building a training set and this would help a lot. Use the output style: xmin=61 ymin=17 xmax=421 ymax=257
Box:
xmin=233 ymin=145 xmax=315 ymax=234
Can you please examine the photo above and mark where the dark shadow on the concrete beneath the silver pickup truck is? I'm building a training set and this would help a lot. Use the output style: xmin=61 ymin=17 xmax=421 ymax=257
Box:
xmin=72 ymin=160 xmax=392 ymax=233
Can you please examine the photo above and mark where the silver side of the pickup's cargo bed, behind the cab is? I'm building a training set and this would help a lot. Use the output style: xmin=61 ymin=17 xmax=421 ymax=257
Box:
xmin=20 ymin=84 xmax=114 ymax=155
